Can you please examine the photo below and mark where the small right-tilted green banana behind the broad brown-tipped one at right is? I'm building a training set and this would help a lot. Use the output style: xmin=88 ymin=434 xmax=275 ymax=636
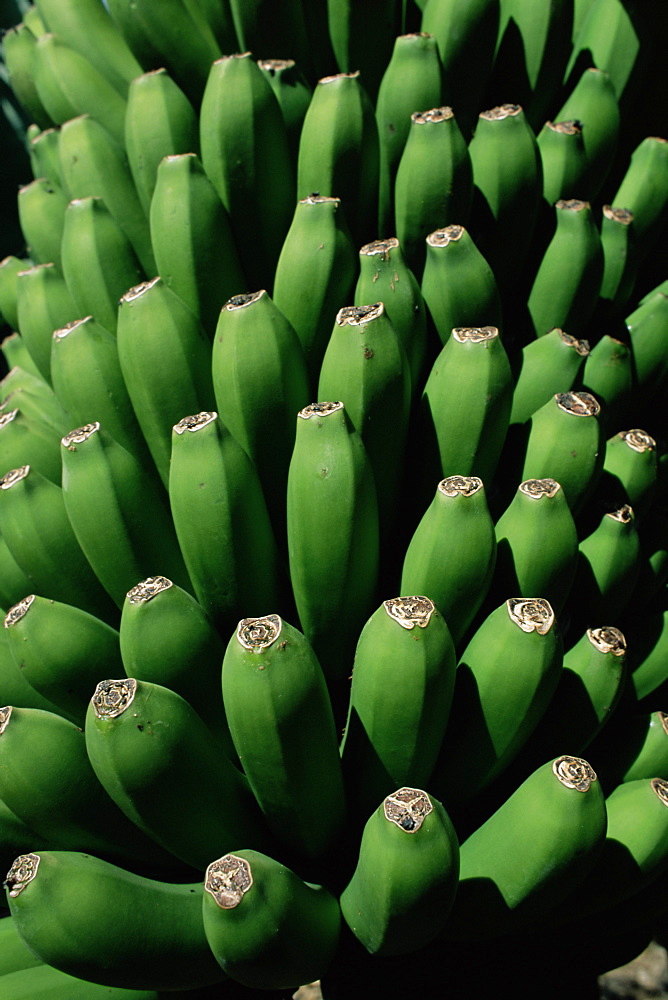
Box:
xmin=510 ymin=327 xmax=589 ymax=424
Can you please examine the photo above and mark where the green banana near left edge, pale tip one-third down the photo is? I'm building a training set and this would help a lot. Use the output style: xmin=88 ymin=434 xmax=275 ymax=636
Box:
xmin=51 ymin=316 xmax=150 ymax=460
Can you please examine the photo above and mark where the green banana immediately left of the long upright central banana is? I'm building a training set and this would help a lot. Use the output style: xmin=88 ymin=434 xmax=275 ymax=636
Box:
xmin=169 ymin=410 xmax=280 ymax=635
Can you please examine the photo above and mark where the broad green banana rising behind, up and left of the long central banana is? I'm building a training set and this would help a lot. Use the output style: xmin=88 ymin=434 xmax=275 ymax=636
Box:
xmin=211 ymin=290 xmax=310 ymax=540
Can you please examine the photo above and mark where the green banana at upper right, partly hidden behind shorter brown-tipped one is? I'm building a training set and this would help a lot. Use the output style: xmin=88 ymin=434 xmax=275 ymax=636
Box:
xmin=555 ymin=66 xmax=620 ymax=200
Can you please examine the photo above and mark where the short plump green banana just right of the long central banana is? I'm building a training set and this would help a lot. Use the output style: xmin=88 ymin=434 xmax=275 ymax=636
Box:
xmin=401 ymin=476 xmax=496 ymax=644
